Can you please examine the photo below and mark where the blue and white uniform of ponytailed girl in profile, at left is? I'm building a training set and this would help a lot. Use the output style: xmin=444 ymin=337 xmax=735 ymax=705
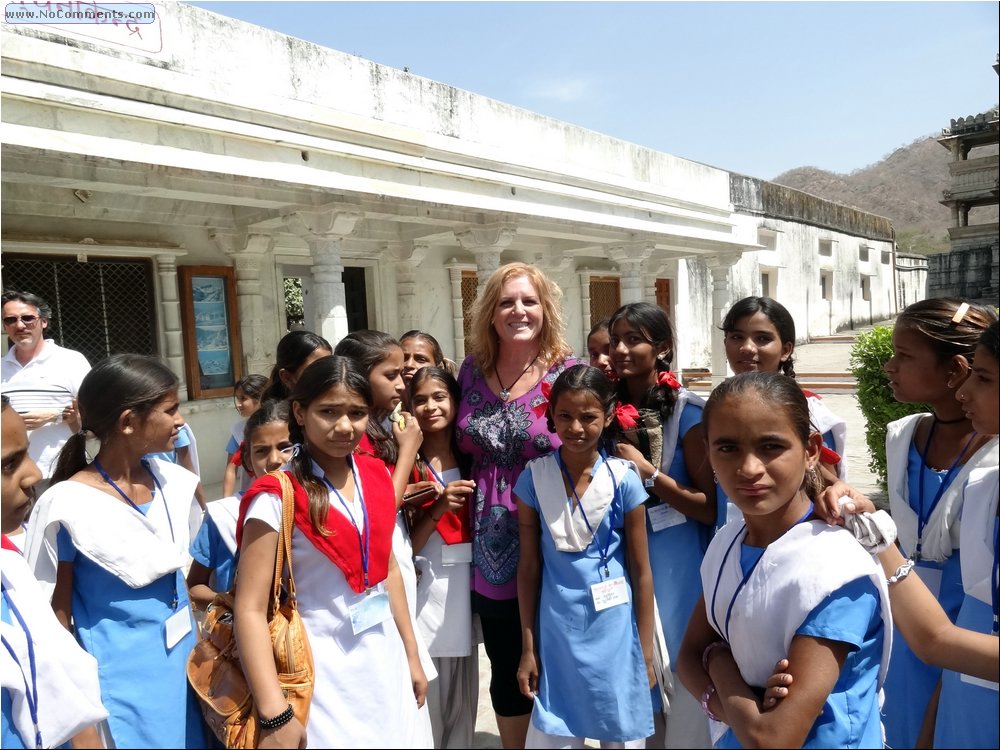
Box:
xmin=27 ymin=459 xmax=205 ymax=748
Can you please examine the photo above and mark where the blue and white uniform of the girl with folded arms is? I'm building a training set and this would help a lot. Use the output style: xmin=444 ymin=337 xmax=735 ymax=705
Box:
xmin=701 ymin=520 xmax=892 ymax=748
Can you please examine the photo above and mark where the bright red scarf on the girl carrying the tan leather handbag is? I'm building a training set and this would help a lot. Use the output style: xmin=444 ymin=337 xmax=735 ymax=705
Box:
xmin=236 ymin=453 xmax=396 ymax=594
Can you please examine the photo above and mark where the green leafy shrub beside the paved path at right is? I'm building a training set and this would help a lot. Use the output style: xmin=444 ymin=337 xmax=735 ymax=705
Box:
xmin=850 ymin=326 xmax=929 ymax=489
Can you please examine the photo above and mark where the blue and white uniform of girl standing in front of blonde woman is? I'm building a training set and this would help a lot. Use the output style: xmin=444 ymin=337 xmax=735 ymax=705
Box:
xmin=514 ymin=453 xmax=653 ymax=742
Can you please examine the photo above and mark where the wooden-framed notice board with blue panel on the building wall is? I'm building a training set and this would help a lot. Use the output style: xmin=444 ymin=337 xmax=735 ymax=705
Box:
xmin=177 ymin=266 xmax=243 ymax=399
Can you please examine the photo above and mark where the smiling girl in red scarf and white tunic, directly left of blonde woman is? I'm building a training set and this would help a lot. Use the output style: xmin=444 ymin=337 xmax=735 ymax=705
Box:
xmin=406 ymin=367 xmax=479 ymax=748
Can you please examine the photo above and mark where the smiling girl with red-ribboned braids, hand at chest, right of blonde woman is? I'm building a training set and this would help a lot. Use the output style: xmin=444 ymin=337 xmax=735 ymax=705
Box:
xmin=609 ymin=302 xmax=716 ymax=748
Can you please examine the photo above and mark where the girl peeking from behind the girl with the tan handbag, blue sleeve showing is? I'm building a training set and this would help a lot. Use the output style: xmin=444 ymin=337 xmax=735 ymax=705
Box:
xmin=187 ymin=400 xmax=292 ymax=609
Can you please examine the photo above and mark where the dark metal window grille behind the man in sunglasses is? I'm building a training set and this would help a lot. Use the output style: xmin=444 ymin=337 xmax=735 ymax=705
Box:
xmin=3 ymin=253 xmax=158 ymax=364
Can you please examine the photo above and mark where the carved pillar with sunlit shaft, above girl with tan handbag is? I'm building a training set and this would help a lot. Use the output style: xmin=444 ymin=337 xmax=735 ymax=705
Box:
xmin=283 ymin=208 xmax=362 ymax=346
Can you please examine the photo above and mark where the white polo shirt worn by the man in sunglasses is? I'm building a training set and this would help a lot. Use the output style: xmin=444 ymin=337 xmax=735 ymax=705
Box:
xmin=0 ymin=339 xmax=90 ymax=479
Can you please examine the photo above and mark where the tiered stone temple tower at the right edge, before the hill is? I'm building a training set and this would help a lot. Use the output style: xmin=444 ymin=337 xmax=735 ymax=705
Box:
xmin=927 ymin=56 xmax=1000 ymax=305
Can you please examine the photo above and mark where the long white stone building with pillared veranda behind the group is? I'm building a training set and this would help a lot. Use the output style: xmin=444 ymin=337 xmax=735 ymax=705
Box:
xmin=0 ymin=2 xmax=924 ymax=494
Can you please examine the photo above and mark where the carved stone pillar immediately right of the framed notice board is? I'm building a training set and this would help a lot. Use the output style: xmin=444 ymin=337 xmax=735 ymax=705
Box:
xmin=209 ymin=232 xmax=274 ymax=375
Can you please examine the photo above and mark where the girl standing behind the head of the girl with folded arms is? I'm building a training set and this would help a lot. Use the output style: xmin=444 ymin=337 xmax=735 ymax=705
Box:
xmin=722 ymin=297 xmax=847 ymax=484
